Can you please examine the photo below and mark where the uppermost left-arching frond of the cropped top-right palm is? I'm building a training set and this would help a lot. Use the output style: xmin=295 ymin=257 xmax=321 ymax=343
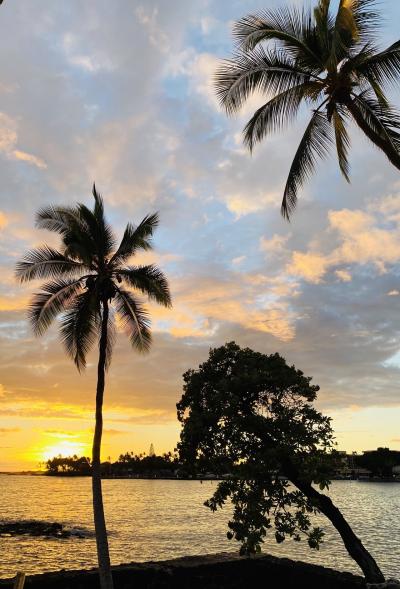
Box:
xmin=233 ymin=7 xmax=323 ymax=71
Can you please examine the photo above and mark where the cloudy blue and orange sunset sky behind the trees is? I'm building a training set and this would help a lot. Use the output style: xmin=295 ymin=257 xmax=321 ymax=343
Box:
xmin=0 ymin=0 xmax=400 ymax=471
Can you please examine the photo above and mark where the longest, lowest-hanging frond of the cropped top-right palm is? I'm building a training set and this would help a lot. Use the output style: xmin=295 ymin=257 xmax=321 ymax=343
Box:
xmin=281 ymin=110 xmax=333 ymax=219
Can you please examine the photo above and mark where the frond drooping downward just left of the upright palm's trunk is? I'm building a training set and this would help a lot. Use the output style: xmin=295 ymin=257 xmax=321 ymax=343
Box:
xmin=61 ymin=289 xmax=101 ymax=372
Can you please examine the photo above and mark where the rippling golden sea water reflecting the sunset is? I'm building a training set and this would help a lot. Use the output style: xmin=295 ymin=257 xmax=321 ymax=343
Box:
xmin=0 ymin=475 xmax=400 ymax=577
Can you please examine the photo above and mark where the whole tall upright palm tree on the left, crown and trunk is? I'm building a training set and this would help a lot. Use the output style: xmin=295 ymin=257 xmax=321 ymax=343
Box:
xmin=16 ymin=186 xmax=171 ymax=589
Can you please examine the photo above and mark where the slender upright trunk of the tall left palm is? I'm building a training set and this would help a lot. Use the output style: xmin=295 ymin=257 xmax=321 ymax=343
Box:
xmin=92 ymin=300 xmax=113 ymax=589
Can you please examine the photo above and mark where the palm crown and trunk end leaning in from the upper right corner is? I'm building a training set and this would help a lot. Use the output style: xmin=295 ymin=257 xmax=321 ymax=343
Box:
xmin=216 ymin=0 xmax=400 ymax=218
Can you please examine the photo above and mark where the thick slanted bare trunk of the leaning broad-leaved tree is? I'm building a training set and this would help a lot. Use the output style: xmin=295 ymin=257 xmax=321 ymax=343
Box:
xmin=282 ymin=457 xmax=385 ymax=583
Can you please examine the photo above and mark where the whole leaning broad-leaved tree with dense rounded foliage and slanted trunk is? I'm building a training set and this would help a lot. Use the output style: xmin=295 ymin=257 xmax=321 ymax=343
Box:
xmin=177 ymin=342 xmax=384 ymax=583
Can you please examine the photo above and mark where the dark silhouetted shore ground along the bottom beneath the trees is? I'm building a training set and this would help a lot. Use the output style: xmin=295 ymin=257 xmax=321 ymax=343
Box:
xmin=0 ymin=554 xmax=366 ymax=589
